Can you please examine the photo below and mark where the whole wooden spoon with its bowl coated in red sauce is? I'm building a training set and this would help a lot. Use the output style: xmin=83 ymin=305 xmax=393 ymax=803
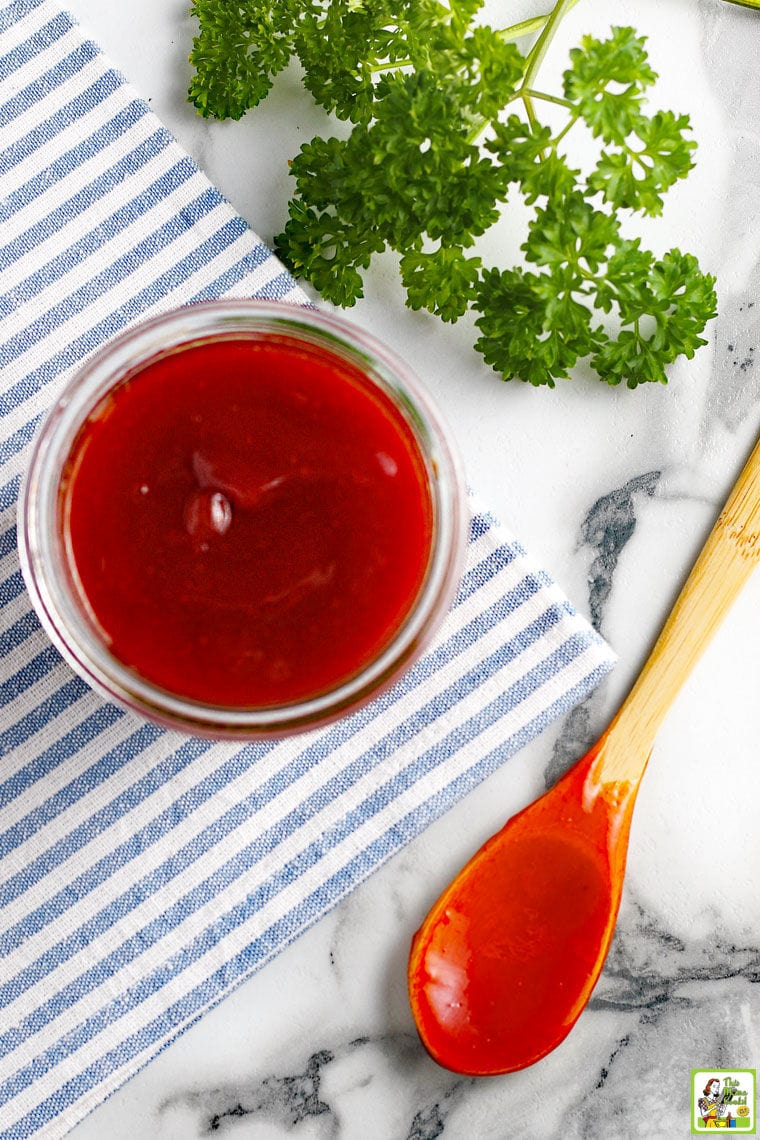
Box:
xmin=409 ymin=433 xmax=760 ymax=1076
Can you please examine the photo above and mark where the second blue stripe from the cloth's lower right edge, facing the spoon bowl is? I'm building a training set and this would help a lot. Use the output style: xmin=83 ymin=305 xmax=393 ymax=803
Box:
xmin=0 ymin=634 xmax=591 ymax=1115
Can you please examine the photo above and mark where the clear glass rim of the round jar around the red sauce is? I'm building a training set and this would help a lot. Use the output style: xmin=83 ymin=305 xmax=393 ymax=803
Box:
xmin=18 ymin=300 xmax=468 ymax=739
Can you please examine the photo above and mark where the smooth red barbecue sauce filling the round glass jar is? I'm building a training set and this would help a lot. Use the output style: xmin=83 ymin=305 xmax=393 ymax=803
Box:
xmin=59 ymin=337 xmax=432 ymax=708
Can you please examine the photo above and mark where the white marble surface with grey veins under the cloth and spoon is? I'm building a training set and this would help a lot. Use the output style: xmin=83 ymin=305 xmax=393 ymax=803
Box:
xmin=59 ymin=0 xmax=760 ymax=1140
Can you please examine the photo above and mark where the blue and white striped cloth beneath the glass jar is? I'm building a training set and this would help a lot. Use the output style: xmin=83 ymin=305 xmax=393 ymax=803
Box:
xmin=0 ymin=0 xmax=612 ymax=1137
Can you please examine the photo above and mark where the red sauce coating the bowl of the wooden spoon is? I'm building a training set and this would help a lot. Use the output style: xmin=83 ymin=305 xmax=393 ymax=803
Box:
xmin=409 ymin=750 xmax=632 ymax=1076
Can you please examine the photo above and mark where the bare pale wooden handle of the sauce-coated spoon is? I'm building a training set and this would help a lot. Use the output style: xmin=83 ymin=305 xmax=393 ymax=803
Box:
xmin=596 ymin=442 xmax=760 ymax=782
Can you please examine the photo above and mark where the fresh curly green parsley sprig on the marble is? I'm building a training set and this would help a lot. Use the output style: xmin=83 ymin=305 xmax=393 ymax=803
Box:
xmin=190 ymin=0 xmax=716 ymax=388
